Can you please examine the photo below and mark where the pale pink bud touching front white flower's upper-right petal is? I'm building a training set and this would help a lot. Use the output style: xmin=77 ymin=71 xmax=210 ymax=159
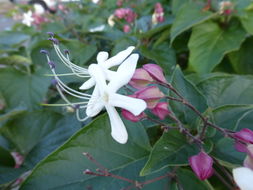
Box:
xmin=129 ymin=68 xmax=153 ymax=89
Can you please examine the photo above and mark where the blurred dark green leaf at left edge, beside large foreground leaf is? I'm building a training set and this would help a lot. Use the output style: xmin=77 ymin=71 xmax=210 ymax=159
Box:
xmin=1 ymin=110 xmax=61 ymax=154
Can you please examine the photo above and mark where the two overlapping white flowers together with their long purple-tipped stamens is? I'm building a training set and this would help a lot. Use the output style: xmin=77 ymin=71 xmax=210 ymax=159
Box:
xmin=41 ymin=33 xmax=147 ymax=144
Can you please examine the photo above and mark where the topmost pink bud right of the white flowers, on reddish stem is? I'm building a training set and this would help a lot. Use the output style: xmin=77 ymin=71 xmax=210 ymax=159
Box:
xmin=143 ymin=63 xmax=167 ymax=83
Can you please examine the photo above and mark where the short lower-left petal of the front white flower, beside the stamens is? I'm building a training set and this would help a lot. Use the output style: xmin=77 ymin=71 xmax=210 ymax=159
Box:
xmin=86 ymin=86 xmax=104 ymax=117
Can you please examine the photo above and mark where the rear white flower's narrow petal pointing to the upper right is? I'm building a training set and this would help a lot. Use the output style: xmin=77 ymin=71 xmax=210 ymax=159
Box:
xmin=105 ymin=46 xmax=135 ymax=68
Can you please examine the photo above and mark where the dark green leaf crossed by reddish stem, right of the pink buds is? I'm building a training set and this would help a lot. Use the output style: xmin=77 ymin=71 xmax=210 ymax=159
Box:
xmin=170 ymin=67 xmax=207 ymax=124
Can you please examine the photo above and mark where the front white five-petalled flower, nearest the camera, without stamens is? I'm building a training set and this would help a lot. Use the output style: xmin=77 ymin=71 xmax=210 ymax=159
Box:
xmin=86 ymin=58 xmax=147 ymax=144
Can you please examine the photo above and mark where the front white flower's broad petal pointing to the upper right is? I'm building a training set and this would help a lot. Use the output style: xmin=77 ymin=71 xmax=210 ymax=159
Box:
xmin=108 ymin=54 xmax=139 ymax=92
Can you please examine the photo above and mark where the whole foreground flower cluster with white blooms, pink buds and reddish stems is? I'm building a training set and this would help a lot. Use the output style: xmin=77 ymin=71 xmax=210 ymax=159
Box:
xmin=41 ymin=33 xmax=253 ymax=190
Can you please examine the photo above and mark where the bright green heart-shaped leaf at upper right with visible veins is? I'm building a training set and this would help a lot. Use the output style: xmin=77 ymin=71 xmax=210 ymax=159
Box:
xmin=188 ymin=21 xmax=246 ymax=73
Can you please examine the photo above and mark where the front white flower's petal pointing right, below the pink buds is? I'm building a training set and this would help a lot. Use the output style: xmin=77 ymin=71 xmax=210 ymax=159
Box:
xmin=109 ymin=93 xmax=147 ymax=116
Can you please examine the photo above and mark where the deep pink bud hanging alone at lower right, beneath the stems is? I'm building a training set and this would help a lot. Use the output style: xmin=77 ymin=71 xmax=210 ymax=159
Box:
xmin=189 ymin=151 xmax=213 ymax=180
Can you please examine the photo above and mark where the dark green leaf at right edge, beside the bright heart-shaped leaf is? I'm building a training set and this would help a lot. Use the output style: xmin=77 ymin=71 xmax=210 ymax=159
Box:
xmin=229 ymin=37 xmax=253 ymax=74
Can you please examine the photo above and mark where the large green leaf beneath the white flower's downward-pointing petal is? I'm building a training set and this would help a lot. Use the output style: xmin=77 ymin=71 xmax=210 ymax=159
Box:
xmin=18 ymin=115 xmax=163 ymax=190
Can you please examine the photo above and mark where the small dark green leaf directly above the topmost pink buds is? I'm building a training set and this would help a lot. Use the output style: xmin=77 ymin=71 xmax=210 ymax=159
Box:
xmin=140 ymin=43 xmax=176 ymax=75
